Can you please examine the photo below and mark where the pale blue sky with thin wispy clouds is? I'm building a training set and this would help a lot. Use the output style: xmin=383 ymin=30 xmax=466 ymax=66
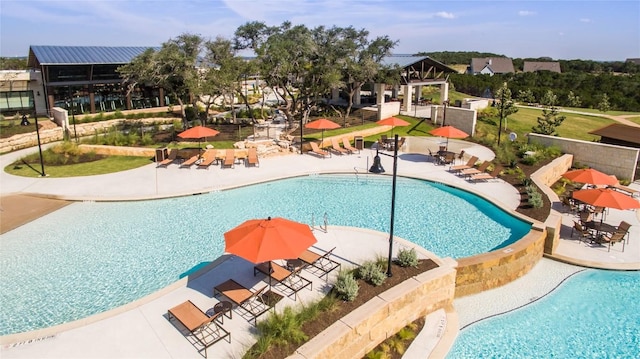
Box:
xmin=0 ymin=0 xmax=640 ymax=61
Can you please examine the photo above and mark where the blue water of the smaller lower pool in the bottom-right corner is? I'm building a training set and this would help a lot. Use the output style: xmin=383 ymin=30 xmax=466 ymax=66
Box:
xmin=447 ymin=270 xmax=640 ymax=359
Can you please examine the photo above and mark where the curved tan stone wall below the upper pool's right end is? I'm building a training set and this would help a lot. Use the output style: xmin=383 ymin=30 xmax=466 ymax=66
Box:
xmin=456 ymin=223 xmax=547 ymax=298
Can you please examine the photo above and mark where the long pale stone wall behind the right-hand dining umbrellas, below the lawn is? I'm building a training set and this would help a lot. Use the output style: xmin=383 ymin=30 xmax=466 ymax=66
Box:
xmin=528 ymin=133 xmax=640 ymax=181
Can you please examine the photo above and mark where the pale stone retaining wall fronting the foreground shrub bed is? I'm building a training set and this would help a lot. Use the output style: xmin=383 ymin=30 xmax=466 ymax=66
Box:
xmin=289 ymin=258 xmax=456 ymax=359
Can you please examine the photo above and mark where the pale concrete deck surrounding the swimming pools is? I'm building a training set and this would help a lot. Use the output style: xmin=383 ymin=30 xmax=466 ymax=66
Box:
xmin=0 ymin=141 xmax=640 ymax=358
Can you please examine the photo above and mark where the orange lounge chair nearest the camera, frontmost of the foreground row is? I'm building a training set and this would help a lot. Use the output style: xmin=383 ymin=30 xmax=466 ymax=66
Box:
xmin=167 ymin=300 xmax=231 ymax=358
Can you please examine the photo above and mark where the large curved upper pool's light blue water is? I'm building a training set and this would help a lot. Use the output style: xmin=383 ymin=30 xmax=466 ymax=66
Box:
xmin=0 ymin=175 xmax=531 ymax=335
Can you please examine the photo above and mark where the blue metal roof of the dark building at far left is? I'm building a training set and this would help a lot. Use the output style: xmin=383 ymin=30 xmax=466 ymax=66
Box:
xmin=30 ymin=46 xmax=159 ymax=65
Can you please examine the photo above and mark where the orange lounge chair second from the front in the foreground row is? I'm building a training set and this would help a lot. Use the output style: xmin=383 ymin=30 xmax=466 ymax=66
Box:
xmin=213 ymin=279 xmax=271 ymax=325
